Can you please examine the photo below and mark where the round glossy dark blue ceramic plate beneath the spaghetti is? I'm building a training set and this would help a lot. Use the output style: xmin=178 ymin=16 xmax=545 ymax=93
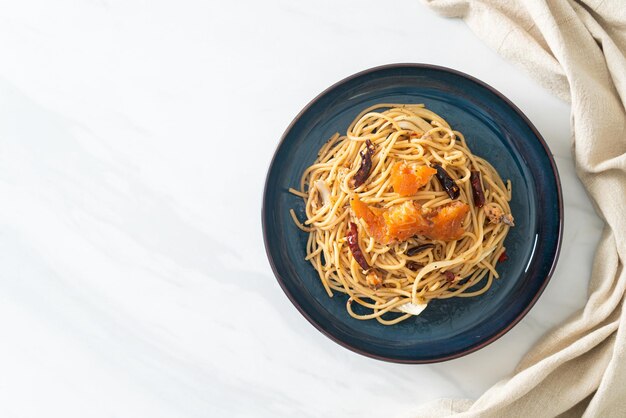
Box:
xmin=262 ymin=64 xmax=563 ymax=363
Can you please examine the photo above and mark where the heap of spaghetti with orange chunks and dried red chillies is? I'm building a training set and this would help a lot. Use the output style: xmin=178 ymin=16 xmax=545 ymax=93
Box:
xmin=290 ymin=103 xmax=513 ymax=325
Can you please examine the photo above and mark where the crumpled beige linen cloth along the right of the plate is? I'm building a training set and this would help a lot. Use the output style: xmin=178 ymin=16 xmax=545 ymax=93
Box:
xmin=415 ymin=0 xmax=626 ymax=418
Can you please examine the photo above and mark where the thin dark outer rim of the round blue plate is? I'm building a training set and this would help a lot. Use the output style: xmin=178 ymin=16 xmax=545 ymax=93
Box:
xmin=261 ymin=63 xmax=564 ymax=364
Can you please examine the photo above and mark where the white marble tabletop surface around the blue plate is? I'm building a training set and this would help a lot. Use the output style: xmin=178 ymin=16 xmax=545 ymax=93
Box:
xmin=0 ymin=0 xmax=602 ymax=418
